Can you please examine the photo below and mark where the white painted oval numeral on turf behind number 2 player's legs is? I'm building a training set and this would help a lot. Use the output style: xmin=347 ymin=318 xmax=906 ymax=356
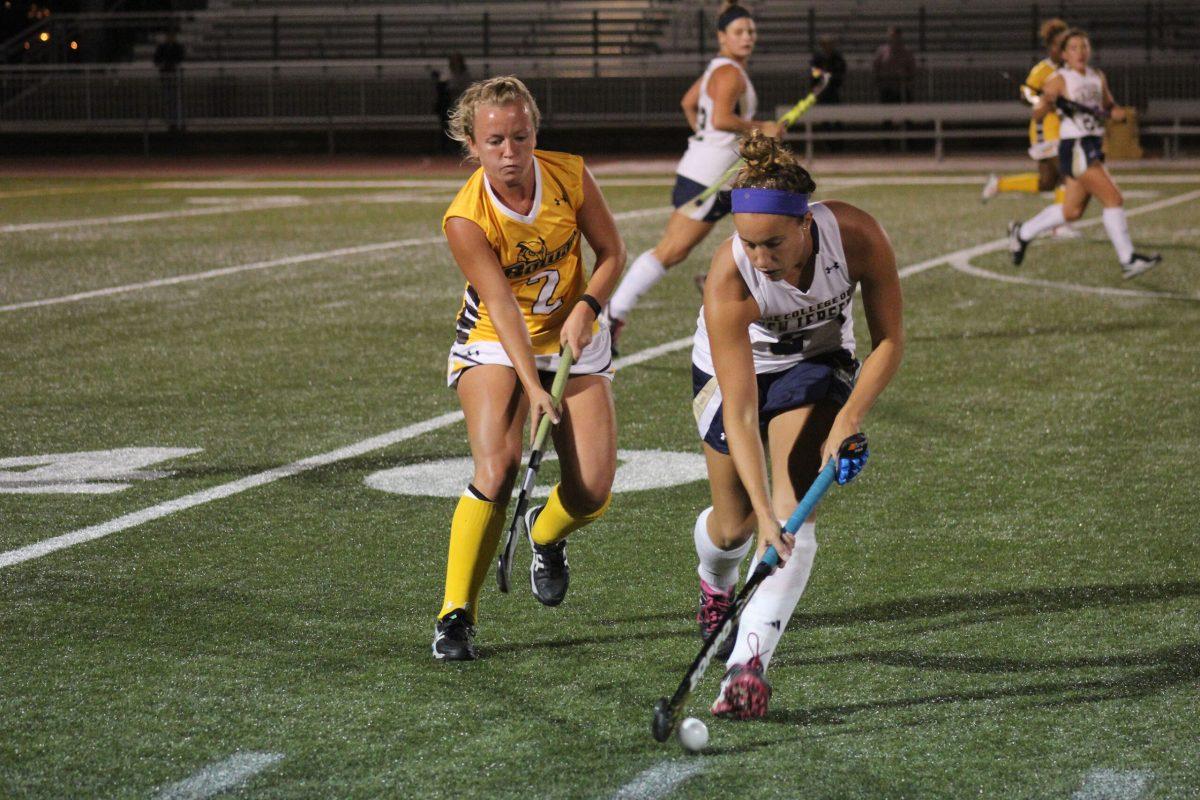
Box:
xmin=364 ymin=450 xmax=706 ymax=498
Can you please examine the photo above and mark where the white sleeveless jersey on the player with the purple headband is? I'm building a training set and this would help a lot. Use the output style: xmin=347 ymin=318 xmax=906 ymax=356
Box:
xmin=691 ymin=203 xmax=857 ymax=375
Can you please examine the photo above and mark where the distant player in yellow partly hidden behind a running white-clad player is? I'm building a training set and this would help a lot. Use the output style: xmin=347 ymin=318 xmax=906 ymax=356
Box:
xmin=983 ymin=18 xmax=1079 ymax=239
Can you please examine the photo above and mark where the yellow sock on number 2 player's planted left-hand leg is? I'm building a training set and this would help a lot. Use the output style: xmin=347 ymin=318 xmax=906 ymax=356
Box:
xmin=438 ymin=488 xmax=505 ymax=620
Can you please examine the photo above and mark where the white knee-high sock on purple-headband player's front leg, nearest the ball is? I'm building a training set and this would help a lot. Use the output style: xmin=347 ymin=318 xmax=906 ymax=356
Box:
xmin=726 ymin=522 xmax=817 ymax=670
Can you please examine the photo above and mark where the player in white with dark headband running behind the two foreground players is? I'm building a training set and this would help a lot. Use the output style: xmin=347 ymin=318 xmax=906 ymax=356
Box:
xmin=606 ymin=4 xmax=779 ymax=343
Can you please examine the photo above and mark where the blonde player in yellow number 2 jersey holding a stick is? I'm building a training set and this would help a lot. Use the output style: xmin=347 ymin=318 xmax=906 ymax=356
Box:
xmin=433 ymin=77 xmax=625 ymax=661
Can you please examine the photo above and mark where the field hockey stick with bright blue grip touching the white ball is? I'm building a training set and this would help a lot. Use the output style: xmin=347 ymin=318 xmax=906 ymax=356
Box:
xmin=650 ymin=433 xmax=866 ymax=741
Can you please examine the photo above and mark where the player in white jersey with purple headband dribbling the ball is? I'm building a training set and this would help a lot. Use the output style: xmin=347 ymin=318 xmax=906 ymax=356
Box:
xmin=692 ymin=133 xmax=905 ymax=718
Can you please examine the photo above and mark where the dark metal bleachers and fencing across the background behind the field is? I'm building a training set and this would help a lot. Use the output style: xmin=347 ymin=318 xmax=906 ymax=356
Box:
xmin=0 ymin=0 xmax=1200 ymax=155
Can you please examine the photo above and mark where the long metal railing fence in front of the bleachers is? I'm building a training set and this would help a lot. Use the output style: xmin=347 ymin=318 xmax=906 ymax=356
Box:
xmin=0 ymin=64 xmax=1200 ymax=132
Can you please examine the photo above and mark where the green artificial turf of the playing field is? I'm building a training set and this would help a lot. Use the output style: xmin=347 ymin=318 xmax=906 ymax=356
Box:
xmin=0 ymin=173 xmax=1200 ymax=799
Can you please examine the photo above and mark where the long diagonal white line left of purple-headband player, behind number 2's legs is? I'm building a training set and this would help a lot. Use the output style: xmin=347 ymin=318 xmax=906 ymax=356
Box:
xmin=0 ymin=336 xmax=691 ymax=569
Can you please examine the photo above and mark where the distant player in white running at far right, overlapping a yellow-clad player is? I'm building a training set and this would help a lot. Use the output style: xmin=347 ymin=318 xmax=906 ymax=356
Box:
xmin=1008 ymin=29 xmax=1162 ymax=278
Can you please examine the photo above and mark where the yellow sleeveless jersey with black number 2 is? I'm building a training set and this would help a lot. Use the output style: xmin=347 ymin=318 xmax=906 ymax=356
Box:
xmin=442 ymin=150 xmax=587 ymax=355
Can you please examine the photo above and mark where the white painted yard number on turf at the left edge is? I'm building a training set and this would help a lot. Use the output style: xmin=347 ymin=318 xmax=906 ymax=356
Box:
xmin=0 ymin=447 xmax=200 ymax=494
